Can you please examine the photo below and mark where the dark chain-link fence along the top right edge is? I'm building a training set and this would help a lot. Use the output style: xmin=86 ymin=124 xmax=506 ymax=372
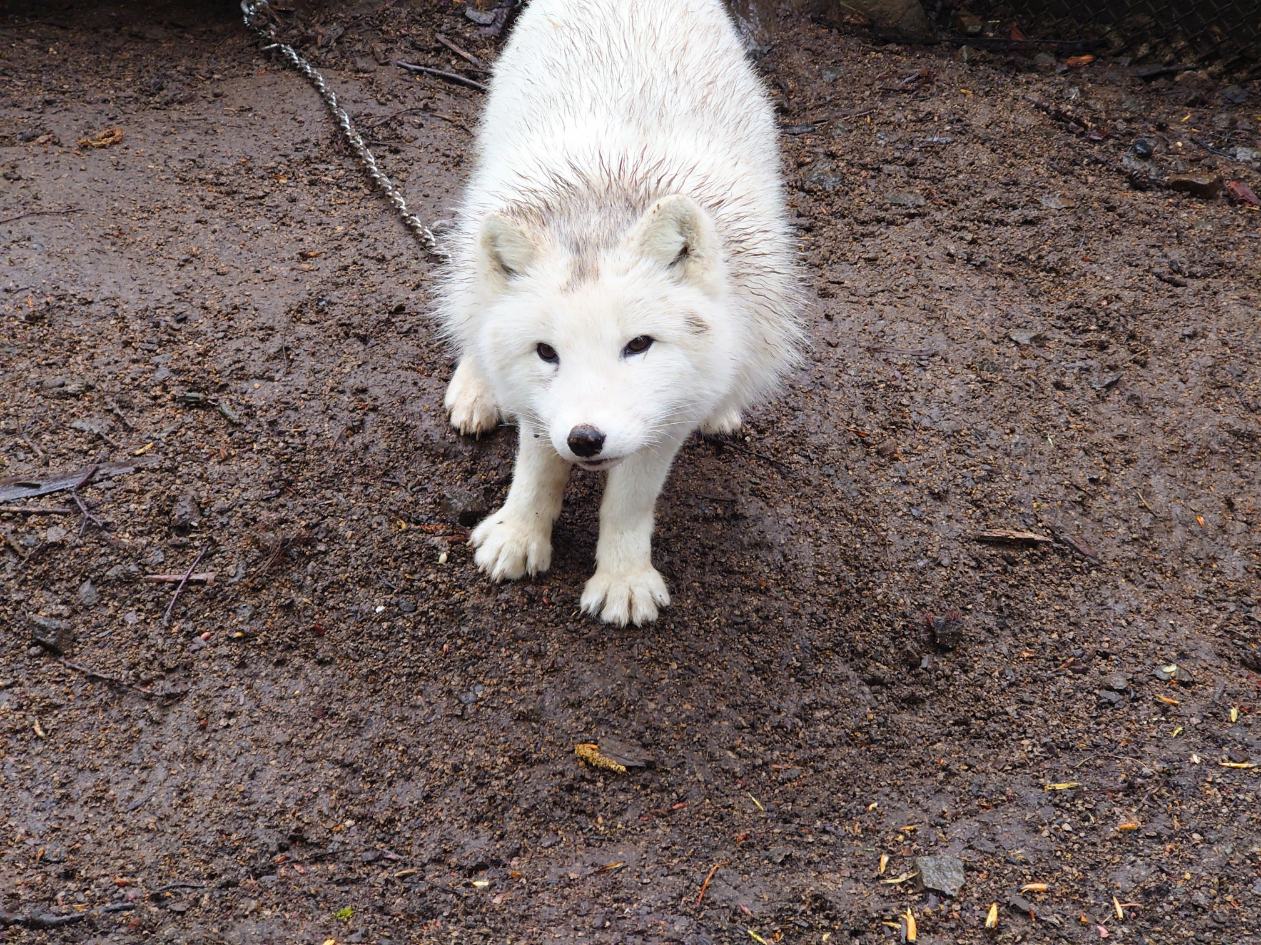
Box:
xmin=938 ymin=0 xmax=1261 ymax=67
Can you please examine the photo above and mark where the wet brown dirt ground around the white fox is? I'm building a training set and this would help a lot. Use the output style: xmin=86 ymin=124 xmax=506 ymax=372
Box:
xmin=0 ymin=0 xmax=1261 ymax=945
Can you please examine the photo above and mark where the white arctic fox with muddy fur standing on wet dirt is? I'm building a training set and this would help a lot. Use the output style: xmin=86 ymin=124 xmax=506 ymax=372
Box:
xmin=439 ymin=0 xmax=802 ymax=625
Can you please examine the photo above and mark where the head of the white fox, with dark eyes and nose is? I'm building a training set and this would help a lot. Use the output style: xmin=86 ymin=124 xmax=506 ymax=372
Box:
xmin=474 ymin=194 xmax=738 ymax=469
